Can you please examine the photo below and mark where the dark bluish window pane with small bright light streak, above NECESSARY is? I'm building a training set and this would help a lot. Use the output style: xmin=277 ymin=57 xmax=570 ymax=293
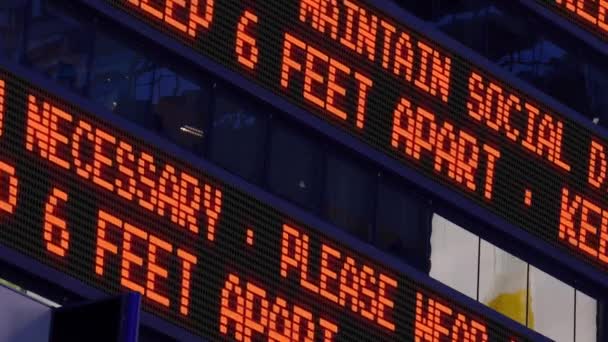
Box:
xmin=152 ymin=68 xmax=211 ymax=150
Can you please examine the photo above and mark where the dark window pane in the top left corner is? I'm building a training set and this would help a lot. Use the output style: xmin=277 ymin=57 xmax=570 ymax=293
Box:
xmin=0 ymin=0 xmax=26 ymax=60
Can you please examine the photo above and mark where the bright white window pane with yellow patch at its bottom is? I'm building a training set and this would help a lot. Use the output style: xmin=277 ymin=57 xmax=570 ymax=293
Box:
xmin=479 ymin=240 xmax=529 ymax=325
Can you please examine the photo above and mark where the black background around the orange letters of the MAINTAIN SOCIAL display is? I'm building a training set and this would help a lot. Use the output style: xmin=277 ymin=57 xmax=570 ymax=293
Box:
xmin=106 ymin=0 xmax=608 ymax=278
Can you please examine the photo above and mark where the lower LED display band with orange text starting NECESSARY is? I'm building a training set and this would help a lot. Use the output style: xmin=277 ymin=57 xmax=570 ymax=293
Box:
xmin=0 ymin=70 xmax=538 ymax=341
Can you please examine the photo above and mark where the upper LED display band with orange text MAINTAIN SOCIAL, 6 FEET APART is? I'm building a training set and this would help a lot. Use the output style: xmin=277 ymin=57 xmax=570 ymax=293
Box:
xmin=92 ymin=0 xmax=608 ymax=280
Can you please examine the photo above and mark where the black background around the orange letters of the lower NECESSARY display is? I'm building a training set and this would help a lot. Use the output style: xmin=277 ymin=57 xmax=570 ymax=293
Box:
xmin=0 ymin=72 xmax=536 ymax=341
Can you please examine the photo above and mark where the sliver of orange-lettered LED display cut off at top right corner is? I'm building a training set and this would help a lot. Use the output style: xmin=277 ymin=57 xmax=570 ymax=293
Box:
xmin=536 ymin=0 xmax=608 ymax=42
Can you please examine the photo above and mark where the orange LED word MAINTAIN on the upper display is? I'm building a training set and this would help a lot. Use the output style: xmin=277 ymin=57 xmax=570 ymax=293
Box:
xmin=299 ymin=0 xmax=452 ymax=102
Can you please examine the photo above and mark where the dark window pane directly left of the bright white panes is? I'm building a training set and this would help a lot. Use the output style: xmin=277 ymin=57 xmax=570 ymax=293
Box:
xmin=375 ymin=177 xmax=430 ymax=272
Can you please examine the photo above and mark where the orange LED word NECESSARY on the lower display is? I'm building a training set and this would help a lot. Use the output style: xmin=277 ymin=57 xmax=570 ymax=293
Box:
xmin=26 ymin=95 xmax=222 ymax=241
